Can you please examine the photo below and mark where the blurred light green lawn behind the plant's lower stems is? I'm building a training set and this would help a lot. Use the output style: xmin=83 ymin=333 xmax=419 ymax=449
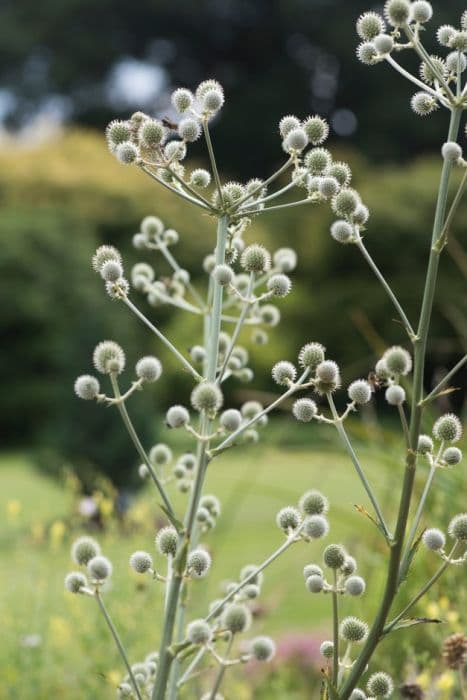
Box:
xmin=0 ymin=434 xmax=464 ymax=700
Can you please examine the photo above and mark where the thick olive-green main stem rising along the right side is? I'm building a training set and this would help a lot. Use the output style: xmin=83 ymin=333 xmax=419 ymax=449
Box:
xmin=340 ymin=108 xmax=462 ymax=700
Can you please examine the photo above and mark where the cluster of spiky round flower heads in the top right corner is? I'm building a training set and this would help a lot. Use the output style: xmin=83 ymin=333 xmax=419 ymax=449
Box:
xmin=356 ymin=0 xmax=467 ymax=116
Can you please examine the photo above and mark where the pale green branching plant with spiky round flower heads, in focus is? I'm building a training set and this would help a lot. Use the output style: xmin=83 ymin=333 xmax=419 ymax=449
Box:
xmin=65 ymin=0 xmax=467 ymax=700
